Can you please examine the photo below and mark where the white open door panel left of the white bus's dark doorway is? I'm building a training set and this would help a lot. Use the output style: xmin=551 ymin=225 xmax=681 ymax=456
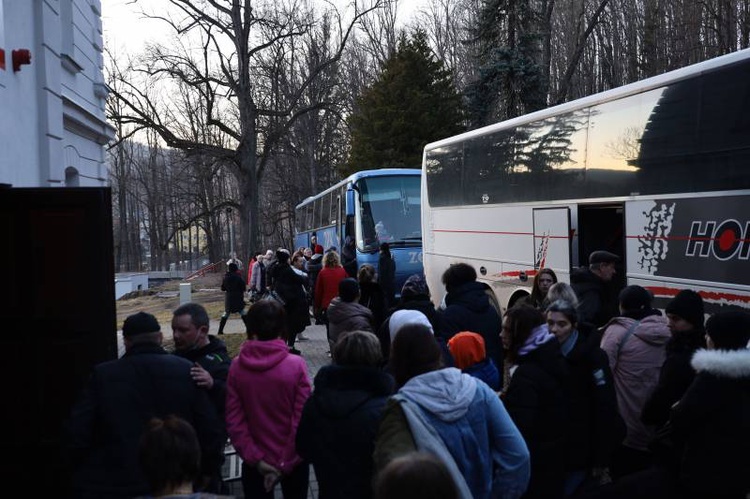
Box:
xmin=534 ymin=207 xmax=570 ymax=273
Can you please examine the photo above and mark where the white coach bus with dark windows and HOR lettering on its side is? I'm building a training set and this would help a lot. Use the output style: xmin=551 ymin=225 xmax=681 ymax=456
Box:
xmin=422 ymin=49 xmax=750 ymax=313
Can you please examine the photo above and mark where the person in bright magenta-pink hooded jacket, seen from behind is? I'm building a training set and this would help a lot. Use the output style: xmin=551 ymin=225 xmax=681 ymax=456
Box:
xmin=226 ymin=300 xmax=310 ymax=499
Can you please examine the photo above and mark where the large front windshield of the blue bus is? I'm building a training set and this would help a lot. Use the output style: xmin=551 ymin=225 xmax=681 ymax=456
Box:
xmin=355 ymin=175 xmax=422 ymax=252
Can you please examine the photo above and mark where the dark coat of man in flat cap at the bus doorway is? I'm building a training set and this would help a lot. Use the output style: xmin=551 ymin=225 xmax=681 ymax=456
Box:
xmin=570 ymin=267 xmax=618 ymax=327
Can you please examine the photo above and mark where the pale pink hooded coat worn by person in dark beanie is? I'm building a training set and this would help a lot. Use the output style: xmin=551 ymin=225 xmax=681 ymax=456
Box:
xmin=601 ymin=311 xmax=671 ymax=451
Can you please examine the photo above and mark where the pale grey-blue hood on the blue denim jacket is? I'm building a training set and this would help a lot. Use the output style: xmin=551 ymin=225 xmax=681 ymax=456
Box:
xmin=399 ymin=367 xmax=477 ymax=422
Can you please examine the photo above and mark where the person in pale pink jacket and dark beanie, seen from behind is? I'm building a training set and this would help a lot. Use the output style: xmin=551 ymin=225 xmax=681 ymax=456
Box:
xmin=601 ymin=285 xmax=671 ymax=479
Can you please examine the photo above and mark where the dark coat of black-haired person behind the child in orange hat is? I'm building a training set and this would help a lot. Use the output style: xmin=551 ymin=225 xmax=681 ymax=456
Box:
xmin=436 ymin=281 xmax=503 ymax=381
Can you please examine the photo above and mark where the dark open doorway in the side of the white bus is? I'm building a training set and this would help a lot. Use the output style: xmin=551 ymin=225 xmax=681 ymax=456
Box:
xmin=577 ymin=203 xmax=627 ymax=290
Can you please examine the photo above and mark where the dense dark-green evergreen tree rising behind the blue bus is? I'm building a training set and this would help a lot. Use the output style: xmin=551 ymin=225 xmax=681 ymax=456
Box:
xmin=342 ymin=31 xmax=463 ymax=175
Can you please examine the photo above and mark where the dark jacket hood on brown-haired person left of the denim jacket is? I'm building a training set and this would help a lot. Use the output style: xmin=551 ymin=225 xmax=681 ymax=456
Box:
xmin=313 ymin=365 xmax=396 ymax=419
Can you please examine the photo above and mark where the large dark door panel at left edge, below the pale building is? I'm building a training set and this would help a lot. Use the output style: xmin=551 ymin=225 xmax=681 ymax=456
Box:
xmin=0 ymin=188 xmax=117 ymax=498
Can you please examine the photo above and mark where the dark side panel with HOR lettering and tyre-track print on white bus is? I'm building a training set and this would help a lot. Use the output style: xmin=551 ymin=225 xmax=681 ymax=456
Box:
xmin=626 ymin=195 xmax=750 ymax=311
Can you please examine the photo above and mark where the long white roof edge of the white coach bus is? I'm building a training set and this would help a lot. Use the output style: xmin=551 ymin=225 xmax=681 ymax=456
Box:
xmin=425 ymin=48 xmax=750 ymax=150
